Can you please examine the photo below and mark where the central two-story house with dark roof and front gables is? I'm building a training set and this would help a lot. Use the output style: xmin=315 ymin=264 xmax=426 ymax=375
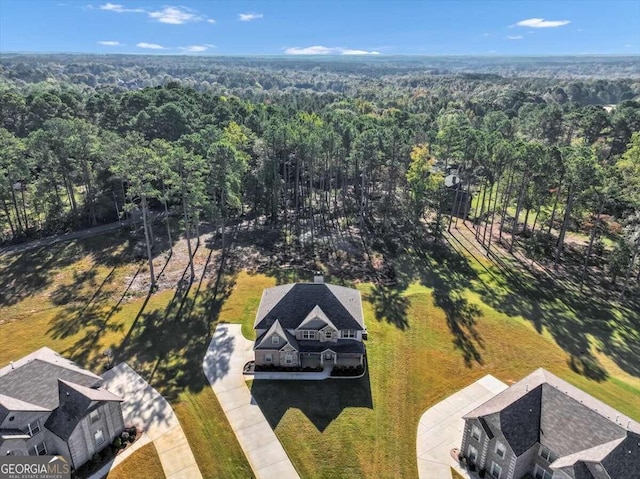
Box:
xmin=253 ymin=276 xmax=366 ymax=367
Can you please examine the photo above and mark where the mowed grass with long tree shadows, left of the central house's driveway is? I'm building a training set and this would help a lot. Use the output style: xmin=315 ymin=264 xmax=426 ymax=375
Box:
xmin=0 ymin=237 xmax=253 ymax=479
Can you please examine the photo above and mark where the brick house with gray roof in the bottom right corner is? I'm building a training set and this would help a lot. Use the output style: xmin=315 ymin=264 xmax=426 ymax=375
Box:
xmin=461 ymin=369 xmax=640 ymax=479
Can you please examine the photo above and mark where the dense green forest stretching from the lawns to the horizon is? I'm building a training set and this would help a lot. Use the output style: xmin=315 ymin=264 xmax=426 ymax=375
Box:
xmin=0 ymin=55 xmax=640 ymax=296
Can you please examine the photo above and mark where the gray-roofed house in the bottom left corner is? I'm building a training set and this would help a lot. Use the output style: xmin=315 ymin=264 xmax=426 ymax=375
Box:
xmin=0 ymin=348 xmax=124 ymax=469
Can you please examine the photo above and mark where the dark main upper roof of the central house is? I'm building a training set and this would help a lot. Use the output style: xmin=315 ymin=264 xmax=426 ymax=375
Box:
xmin=253 ymin=283 xmax=364 ymax=330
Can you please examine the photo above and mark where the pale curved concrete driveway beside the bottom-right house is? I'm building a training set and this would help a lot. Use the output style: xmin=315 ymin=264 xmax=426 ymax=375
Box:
xmin=416 ymin=375 xmax=507 ymax=479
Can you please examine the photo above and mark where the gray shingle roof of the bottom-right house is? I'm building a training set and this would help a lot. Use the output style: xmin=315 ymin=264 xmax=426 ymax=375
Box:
xmin=464 ymin=369 xmax=640 ymax=479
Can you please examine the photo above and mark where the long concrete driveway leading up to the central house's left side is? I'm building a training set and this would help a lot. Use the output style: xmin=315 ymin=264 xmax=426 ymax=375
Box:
xmin=202 ymin=324 xmax=299 ymax=479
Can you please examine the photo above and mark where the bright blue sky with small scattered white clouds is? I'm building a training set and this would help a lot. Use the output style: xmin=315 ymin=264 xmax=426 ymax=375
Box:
xmin=0 ymin=0 xmax=640 ymax=55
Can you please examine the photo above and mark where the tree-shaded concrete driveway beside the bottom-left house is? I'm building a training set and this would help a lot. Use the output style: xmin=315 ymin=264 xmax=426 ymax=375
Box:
xmin=103 ymin=363 xmax=202 ymax=479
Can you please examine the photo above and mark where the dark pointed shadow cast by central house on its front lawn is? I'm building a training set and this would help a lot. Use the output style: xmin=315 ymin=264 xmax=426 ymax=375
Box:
xmin=251 ymin=371 xmax=373 ymax=432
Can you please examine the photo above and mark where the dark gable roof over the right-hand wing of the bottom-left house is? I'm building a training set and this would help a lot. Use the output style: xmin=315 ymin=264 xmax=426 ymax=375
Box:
xmin=45 ymin=380 xmax=122 ymax=441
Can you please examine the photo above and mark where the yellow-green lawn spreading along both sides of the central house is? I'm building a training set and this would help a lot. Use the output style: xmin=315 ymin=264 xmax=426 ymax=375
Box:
xmin=0 ymin=232 xmax=640 ymax=479
